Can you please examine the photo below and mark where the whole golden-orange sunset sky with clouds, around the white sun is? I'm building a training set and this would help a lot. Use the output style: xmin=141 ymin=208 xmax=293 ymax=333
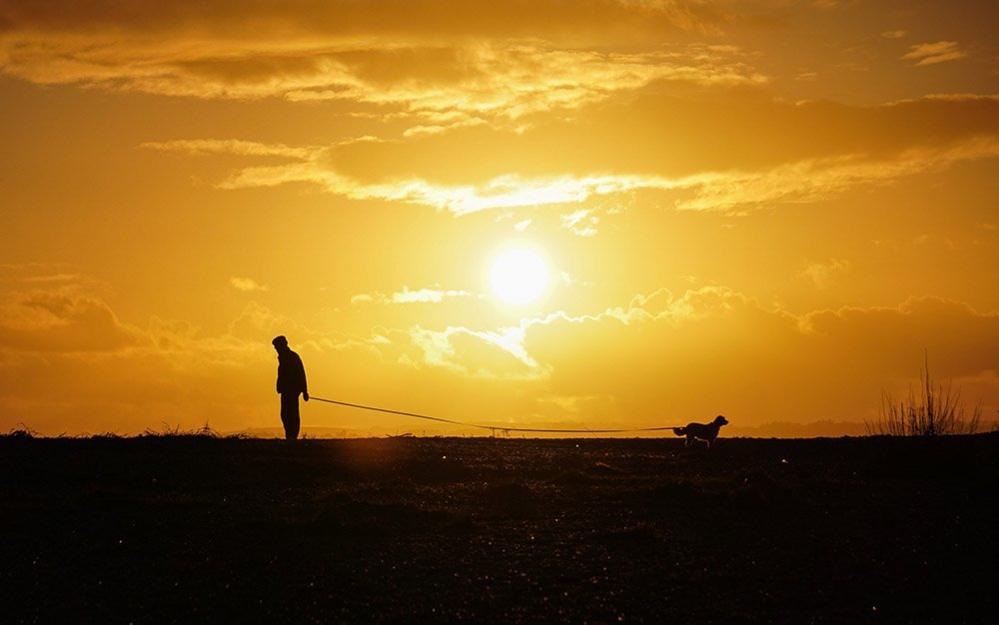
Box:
xmin=0 ymin=0 xmax=999 ymax=434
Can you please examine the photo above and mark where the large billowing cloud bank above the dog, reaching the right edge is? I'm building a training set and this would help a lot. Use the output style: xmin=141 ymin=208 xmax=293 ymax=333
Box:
xmin=536 ymin=289 xmax=999 ymax=421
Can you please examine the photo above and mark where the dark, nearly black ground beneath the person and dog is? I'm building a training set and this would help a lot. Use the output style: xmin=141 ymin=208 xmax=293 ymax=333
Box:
xmin=0 ymin=435 xmax=999 ymax=623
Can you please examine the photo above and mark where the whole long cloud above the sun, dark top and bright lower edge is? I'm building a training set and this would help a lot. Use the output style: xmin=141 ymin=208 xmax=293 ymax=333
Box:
xmin=146 ymin=91 xmax=999 ymax=216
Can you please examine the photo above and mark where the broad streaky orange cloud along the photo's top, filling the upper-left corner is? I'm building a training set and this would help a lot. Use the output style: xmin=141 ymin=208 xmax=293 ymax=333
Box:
xmin=0 ymin=0 xmax=765 ymax=118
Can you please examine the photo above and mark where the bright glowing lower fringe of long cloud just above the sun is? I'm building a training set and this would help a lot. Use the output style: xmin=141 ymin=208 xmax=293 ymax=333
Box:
xmin=143 ymin=137 xmax=999 ymax=216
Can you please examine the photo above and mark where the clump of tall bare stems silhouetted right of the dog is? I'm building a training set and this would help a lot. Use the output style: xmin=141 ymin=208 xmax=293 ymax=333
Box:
xmin=866 ymin=354 xmax=982 ymax=436
